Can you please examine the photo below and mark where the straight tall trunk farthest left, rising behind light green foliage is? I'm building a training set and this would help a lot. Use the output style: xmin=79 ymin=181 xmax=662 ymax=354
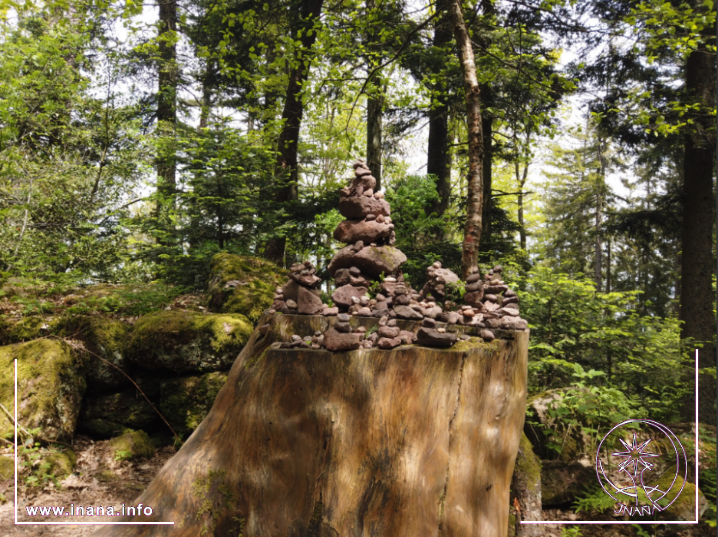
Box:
xmin=156 ymin=0 xmax=179 ymax=205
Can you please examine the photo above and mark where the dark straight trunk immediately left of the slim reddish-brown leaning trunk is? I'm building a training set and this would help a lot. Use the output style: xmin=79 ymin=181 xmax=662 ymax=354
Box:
xmin=426 ymin=0 xmax=453 ymax=216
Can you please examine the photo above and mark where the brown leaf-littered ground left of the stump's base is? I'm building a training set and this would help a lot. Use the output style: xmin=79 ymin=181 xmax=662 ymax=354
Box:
xmin=0 ymin=436 xmax=176 ymax=537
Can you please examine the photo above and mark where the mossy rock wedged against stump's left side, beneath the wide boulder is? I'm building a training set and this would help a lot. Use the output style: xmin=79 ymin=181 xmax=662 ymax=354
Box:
xmin=160 ymin=371 xmax=227 ymax=438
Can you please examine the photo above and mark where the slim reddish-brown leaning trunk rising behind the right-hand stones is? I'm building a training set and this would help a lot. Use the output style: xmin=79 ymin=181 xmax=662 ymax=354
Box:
xmin=449 ymin=0 xmax=484 ymax=278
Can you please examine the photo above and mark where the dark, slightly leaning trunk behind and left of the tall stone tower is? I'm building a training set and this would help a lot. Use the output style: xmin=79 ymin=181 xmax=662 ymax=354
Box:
xmin=264 ymin=0 xmax=324 ymax=266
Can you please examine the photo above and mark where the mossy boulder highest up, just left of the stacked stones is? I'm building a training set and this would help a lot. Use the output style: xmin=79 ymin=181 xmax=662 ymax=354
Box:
xmin=208 ymin=253 xmax=288 ymax=323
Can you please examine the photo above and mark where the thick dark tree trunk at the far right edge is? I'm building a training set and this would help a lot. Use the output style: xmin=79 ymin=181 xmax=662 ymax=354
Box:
xmin=680 ymin=16 xmax=716 ymax=424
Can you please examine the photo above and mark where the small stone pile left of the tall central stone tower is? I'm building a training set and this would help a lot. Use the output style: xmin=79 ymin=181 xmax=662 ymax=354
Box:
xmin=270 ymin=261 xmax=338 ymax=315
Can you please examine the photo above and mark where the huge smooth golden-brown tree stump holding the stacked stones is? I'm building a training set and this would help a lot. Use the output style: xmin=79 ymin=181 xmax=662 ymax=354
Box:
xmin=98 ymin=314 xmax=528 ymax=537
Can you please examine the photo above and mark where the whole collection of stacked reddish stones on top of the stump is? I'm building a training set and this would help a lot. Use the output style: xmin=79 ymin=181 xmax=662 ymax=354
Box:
xmin=262 ymin=160 xmax=528 ymax=351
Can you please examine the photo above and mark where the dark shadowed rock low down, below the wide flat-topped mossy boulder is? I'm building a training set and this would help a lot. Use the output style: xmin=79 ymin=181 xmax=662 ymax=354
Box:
xmin=77 ymin=389 xmax=158 ymax=438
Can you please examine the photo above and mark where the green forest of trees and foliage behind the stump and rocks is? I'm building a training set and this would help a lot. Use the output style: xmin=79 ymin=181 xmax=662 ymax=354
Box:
xmin=0 ymin=0 xmax=716 ymax=501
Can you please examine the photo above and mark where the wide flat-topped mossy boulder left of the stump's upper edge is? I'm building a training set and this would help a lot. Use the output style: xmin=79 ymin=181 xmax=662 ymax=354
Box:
xmin=128 ymin=311 xmax=252 ymax=373
